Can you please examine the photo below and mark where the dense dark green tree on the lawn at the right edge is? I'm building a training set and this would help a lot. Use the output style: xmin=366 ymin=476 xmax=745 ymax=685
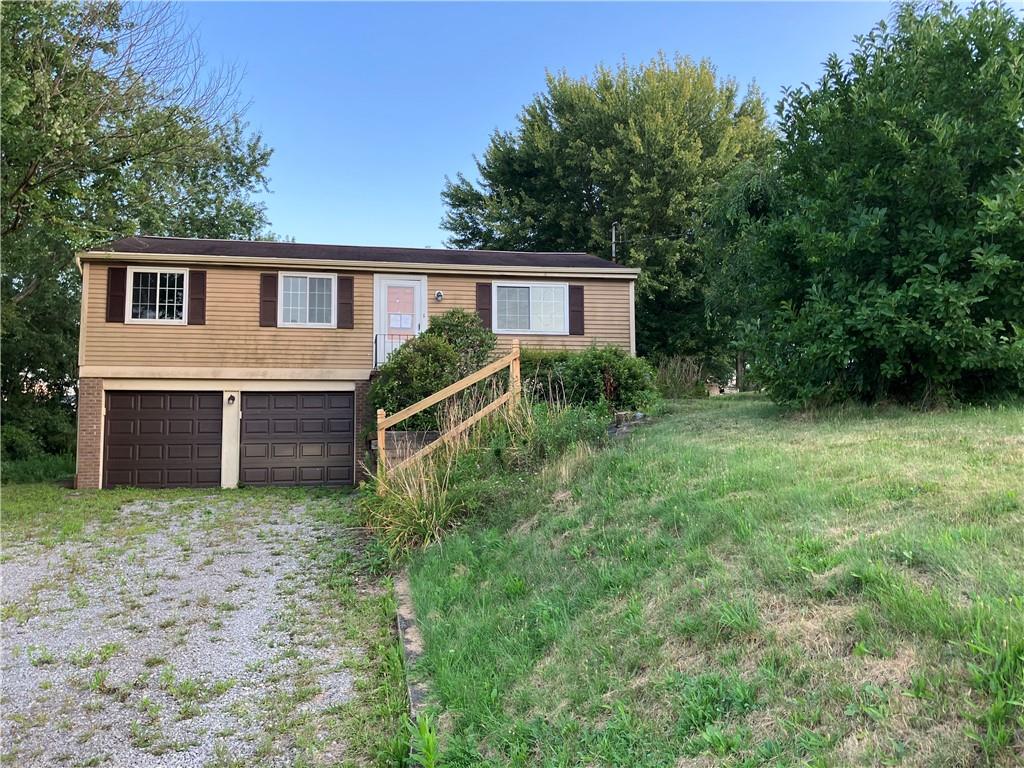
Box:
xmin=746 ymin=4 xmax=1024 ymax=404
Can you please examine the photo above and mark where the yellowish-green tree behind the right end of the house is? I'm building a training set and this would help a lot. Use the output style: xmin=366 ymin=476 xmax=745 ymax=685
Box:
xmin=442 ymin=57 xmax=770 ymax=353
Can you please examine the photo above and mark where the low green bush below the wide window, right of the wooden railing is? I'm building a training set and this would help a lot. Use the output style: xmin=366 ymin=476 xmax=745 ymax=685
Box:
xmin=521 ymin=346 xmax=658 ymax=411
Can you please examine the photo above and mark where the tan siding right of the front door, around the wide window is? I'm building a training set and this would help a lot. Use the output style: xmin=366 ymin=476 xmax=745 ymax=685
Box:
xmin=427 ymin=274 xmax=631 ymax=351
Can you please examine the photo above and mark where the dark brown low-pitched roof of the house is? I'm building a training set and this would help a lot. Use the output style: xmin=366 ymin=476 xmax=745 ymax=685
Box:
xmin=100 ymin=237 xmax=635 ymax=272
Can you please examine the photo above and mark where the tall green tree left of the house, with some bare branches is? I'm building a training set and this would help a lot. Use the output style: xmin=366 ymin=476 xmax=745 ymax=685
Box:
xmin=0 ymin=2 xmax=270 ymax=454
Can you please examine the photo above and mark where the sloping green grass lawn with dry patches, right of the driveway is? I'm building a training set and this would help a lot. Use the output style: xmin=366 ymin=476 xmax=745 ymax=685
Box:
xmin=411 ymin=396 xmax=1024 ymax=766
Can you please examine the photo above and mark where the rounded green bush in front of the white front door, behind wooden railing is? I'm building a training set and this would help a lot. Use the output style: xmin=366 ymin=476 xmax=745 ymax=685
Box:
xmin=367 ymin=309 xmax=497 ymax=430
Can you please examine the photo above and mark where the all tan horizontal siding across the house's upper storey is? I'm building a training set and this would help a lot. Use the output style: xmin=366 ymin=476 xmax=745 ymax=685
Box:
xmin=80 ymin=260 xmax=631 ymax=376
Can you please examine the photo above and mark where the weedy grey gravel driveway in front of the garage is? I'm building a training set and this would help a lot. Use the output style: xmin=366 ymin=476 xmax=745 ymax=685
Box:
xmin=2 ymin=492 xmax=370 ymax=768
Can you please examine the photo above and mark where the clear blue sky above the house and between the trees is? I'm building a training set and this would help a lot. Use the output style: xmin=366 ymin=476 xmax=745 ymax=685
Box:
xmin=182 ymin=2 xmax=891 ymax=247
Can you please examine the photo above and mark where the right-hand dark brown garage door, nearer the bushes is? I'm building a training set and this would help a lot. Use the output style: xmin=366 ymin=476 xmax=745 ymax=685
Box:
xmin=239 ymin=392 xmax=355 ymax=485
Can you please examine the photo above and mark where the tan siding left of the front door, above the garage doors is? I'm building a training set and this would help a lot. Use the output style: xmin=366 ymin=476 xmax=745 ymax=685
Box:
xmin=81 ymin=263 xmax=374 ymax=369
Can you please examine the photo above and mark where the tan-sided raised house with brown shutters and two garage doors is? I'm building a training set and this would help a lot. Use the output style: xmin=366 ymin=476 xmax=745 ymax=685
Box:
xmin=77 ymin=238 xmax=638 ymax=487
